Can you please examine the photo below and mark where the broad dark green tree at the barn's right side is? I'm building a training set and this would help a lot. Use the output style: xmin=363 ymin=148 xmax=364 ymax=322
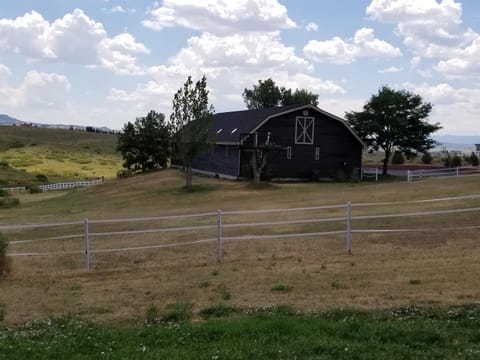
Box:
xmin=345 ymin=86 xmax=441 ymax=175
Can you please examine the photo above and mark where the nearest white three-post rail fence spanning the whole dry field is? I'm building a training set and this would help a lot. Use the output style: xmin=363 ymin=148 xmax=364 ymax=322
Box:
xmin=0 ymin=195 xmax=480 ymax=270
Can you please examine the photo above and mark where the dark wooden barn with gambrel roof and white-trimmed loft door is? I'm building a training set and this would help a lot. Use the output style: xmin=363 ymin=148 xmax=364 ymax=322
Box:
xmin=192 ymin=105 xmax=364 ymax=180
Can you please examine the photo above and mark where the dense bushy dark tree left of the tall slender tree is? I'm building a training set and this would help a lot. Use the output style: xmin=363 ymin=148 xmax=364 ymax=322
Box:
xmin=117 ymin=110 xmax=170 ymax=172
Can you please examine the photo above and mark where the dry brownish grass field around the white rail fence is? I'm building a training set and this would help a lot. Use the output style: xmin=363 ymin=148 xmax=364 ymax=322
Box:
xmin=0 ymin=171 xmax=480 ymax=323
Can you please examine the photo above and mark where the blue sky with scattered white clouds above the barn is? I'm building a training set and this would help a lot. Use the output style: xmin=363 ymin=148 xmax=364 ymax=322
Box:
xmin=0 ymin=0 xmax=480 ymax=135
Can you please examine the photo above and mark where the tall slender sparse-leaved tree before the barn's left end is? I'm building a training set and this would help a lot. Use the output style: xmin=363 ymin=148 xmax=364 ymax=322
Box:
xmin=170 ymin=75 xmax=213 ymax=190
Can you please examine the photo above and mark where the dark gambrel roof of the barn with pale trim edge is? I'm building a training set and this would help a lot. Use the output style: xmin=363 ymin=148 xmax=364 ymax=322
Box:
xmin=212 ymin=105 xmax=364 ymax=147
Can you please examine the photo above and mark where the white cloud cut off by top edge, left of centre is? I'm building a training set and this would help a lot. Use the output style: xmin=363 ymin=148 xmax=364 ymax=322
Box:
xmin=142 ymin=0 xmax=296 ymax=35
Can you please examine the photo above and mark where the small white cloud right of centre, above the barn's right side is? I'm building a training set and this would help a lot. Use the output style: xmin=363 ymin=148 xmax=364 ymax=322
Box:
xmin=303 ymin=28 xmax=402 ymax=64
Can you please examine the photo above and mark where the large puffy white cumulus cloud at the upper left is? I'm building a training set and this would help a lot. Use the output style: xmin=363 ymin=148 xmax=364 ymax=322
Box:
xmin=0 ymin=9 xmax=149 ymax=73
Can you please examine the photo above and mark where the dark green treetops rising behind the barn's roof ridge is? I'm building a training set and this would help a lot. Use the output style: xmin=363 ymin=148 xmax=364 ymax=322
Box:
xmin=242 ymin=78 xmax=318 ymax=110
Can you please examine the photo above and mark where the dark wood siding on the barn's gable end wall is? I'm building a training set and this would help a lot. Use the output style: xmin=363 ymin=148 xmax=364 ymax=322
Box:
xmin=242 ymin=110 xmax=362 ymax=178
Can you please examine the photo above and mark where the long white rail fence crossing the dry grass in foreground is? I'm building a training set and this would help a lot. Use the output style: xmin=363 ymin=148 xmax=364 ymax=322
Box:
xmin=0 ymin=195 xmax=480 ymax=270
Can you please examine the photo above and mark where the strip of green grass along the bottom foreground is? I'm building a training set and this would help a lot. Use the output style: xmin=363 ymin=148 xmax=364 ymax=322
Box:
xmin=0 ymin=306 xmax=480 ymax=360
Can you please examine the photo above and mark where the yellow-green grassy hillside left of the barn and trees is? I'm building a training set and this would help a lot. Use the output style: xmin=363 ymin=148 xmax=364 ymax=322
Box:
xmin=0 ymin=126 xmax=122 ymax=186
